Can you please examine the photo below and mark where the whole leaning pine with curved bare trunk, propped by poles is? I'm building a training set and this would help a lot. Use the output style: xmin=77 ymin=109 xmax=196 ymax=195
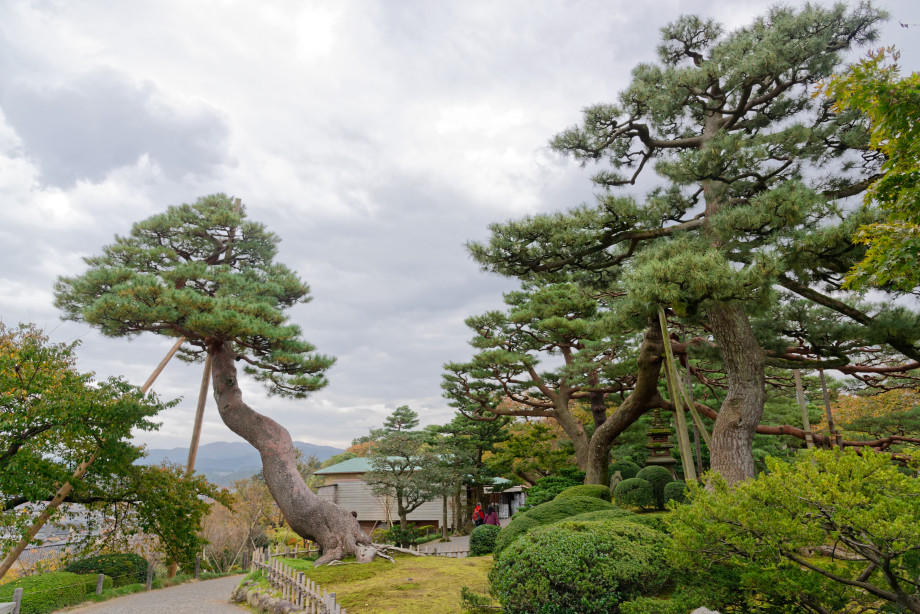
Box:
xmin=55 ymin=194 xmax=375 ymax=565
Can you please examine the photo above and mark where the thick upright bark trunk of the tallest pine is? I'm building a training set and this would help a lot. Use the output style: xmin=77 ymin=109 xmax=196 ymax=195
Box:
xmin=707 ymin=303 xmax=766 ymax=485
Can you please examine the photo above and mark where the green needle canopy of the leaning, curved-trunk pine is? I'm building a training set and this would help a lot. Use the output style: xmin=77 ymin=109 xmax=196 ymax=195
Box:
xmin=55 ymin=194 xmax=334 ymax=397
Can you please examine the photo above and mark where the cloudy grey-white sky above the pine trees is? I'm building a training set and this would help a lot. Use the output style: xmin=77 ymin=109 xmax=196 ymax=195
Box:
xmin=0 ymin=0 xmax=920 ymax=448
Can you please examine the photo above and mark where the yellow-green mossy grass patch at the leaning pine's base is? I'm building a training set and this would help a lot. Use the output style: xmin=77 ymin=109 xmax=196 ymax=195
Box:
xmin=284 ymin=555 xmax=492 ymax=614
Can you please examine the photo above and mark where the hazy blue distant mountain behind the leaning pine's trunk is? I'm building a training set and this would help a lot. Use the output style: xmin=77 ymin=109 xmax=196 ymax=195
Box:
xmin=138 ymin=441 xmax=344 ymax=486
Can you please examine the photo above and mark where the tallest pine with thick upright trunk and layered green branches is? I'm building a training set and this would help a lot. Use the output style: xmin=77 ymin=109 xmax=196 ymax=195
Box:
xmin=470 ymin=3 xmax=885 ymax=483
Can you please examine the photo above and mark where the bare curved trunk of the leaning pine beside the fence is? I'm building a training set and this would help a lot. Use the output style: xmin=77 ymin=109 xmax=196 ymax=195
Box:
xmin=208 ymin=343 xmax=375 ymax=565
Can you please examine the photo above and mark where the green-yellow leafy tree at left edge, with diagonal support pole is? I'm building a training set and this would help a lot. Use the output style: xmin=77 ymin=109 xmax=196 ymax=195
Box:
xmin=0 ymin=323 xmax=223 ymax=567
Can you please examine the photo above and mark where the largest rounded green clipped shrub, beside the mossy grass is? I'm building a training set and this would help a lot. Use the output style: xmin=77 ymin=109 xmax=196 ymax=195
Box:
xmin=489 ymin=520 xmax=670 ymax=614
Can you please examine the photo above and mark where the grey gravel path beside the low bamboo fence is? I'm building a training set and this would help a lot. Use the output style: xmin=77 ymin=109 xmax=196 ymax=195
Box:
xmin=66 ymin=575 xmax=244 ymax=614
